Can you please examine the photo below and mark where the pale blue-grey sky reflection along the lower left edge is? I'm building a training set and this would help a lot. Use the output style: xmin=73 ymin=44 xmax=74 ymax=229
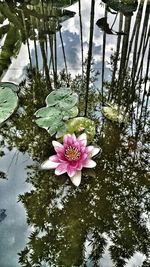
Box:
xmin=0 ymin=149 xmax=31 ymax=267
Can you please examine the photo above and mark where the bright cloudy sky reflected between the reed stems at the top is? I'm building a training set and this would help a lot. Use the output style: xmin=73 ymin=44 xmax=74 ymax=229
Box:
xmin=4 ymin=0 xmax=147 ymax=82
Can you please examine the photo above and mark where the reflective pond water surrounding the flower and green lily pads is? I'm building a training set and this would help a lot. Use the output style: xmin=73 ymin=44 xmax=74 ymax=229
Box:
xmin=0 ymin=0 xmax=150 ymax=267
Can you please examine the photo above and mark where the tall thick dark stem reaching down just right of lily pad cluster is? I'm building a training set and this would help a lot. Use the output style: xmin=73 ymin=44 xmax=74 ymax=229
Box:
xmin=85 ymin=0 xmax=95 ymax=116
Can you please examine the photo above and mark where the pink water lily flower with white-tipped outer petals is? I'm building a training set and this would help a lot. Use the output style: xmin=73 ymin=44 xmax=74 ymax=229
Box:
xmin=41 ymin=133 xmax=100 ymax=186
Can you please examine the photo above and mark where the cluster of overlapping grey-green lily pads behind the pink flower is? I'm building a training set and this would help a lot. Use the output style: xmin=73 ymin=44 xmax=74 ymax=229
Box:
xmin=35 ymin=88 xmax=78 ymax=138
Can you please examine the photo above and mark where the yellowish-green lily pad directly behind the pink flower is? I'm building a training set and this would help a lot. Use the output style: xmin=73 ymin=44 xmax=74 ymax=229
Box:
xmin=66 ymin=117 xmax=95 ymax=142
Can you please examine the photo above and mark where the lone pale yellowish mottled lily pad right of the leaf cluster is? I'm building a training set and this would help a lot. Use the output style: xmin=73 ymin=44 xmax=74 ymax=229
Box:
xmin=102 ymin=104 xmax=128 ymax=123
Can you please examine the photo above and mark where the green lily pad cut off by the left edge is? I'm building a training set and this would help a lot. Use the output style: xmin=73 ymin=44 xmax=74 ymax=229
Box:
xmin=0 ymin=83 xmax=18 ymax=124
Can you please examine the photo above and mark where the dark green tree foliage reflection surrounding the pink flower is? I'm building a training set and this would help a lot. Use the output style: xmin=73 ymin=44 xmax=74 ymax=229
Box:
xmin=1 ymin=63 xmax=149 ymax=267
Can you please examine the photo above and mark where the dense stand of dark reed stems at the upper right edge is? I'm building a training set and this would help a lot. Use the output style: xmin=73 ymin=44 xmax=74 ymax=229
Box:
xmin=102 ymin=1 xmax=150 ymax=141
